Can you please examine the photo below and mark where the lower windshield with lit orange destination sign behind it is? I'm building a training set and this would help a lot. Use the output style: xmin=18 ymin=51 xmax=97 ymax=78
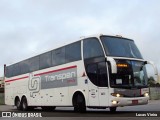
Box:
xmin=110 ymin=60 xmax=148 ymax=88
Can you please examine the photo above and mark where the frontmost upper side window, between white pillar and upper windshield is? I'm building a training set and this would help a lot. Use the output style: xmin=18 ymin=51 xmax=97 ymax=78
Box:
xmin=83 ymin=38 xmax=104 ymax=59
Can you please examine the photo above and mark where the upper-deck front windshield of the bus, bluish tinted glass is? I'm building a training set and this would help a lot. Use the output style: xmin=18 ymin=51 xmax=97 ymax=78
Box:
xmin=101 ymin=36 xmax=142 ymax=59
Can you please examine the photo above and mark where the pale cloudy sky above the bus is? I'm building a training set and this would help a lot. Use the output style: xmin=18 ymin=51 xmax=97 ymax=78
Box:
xmin=0 ymin=0 xmax=160 ymax=79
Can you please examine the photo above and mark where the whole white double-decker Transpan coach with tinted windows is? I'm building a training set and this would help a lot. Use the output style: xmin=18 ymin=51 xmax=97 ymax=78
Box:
xmin=5 ymin=34 xmax=158 ymax=112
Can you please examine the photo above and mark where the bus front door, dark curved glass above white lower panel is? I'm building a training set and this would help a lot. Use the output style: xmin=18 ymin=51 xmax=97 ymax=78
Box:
xmin=86 ymin=62 xmax=109 ymax=107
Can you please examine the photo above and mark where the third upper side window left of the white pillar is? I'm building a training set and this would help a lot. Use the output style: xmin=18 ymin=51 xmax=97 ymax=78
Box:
xmin=39 ymin=52 xmax=52 ymax=69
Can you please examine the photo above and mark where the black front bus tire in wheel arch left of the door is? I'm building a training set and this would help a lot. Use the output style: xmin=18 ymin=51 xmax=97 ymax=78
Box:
xmin=73 ymin=94 xmax=86 ymax=113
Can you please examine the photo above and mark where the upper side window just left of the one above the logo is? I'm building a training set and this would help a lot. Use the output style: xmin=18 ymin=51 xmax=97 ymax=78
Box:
xmin=19 ymin=60 xmax=29 ymax=74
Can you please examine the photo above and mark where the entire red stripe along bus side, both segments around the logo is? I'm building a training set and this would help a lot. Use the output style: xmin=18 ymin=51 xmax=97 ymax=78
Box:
xmin=5 ymin=65 xmax=77 ymax=82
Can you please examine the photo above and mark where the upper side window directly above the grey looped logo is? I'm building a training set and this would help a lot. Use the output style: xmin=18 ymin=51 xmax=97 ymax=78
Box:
xmin=29 ymin=56 xmax=39 ymax=72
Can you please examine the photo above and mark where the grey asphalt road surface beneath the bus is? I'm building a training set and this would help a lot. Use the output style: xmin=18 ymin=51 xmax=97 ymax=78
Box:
xmin=0 ymin=100 xmax=160 ymax=120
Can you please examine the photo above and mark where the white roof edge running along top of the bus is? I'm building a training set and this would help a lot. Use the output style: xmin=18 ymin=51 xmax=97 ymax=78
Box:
xmin=6 ymin=34 xmax=131 ymax=66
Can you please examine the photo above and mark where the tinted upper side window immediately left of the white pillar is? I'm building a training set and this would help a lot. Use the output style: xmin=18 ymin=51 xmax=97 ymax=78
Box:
xmin=65 ymin=42 xmax=81 ymax=63
